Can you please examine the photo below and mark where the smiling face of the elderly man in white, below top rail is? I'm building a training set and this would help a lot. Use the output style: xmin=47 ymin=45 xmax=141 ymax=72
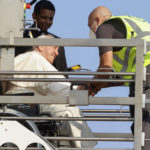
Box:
xmin=41 ymin=46 xmax=59 ymax=64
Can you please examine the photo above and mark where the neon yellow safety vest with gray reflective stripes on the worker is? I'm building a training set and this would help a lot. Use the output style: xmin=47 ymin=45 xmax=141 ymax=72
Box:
xmin=110 ymin=17 xmax=150 ymax=85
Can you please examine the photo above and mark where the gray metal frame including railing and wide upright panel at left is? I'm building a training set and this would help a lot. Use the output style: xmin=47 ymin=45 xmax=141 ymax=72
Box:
xmin=0 ymin=0 xmax=150 ymax=150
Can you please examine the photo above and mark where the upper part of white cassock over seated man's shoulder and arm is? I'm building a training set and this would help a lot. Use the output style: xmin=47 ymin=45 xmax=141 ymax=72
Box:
xmin=12 ymin=51 xmax=71 ymax=96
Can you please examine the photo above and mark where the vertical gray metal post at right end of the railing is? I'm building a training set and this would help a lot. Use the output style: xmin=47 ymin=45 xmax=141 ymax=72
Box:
xmin=134 ymin=41 xmax=146 ymax=150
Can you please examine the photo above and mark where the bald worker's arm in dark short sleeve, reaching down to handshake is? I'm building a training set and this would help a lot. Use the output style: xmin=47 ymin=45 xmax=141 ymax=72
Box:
xmin=91 ymin=24 xmax=113 ymax=88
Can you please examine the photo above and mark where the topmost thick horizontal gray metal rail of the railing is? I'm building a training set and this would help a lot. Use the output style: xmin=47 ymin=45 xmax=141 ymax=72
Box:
xmin=0 ymin=38 xmax=144 ymax=47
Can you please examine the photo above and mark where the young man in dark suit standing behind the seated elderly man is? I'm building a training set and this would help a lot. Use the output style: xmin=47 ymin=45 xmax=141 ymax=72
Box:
xmin=15 ymin=0 xmax=67 ymax=71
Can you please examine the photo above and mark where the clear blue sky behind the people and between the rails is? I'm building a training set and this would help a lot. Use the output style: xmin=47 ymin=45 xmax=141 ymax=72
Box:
xmin=27 ymin=0 xmax=150 ymax=148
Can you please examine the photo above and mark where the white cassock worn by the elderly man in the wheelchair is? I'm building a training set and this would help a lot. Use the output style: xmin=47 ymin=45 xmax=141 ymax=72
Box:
xmin=6 ymin=51 xmax=97 ymax=148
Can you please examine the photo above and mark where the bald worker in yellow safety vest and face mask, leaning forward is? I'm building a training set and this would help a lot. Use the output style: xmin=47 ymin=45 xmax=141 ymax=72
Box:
xmin=88 ymin=6 xmax=150 ymax=150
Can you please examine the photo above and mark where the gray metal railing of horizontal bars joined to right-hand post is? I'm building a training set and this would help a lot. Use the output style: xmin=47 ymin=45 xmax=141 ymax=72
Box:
xmin=0 ymin=38 xmax=146 ymax=150
